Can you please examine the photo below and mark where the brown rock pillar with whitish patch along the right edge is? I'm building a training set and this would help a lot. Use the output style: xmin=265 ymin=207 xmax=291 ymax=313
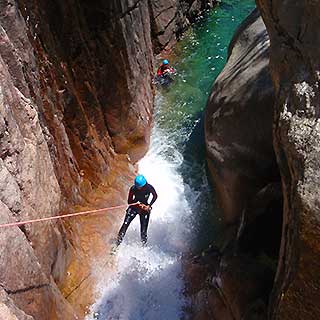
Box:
xmin=257 ymin=0 xmax=320 ymax=320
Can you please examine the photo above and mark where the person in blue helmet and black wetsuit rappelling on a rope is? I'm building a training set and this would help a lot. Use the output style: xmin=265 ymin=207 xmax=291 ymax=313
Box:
xmin=116 ymin=174 xmax=158 ymax=246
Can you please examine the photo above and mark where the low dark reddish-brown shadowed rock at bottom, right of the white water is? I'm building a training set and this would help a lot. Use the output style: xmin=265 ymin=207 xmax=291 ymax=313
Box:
xmin=185 ymin=246 xmax=273 ymax=320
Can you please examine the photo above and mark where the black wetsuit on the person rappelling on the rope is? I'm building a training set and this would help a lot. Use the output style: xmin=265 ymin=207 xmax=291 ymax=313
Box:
xmin=117 ymin=183 xmax=158 ymax=245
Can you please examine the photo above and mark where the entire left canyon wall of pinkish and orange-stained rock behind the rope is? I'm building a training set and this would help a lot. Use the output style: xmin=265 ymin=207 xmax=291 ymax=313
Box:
xmin=0 ymin=0 xmax=216 ymax=320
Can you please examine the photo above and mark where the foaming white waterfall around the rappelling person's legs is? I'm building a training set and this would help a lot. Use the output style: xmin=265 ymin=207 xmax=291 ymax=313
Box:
xmin=86 ymin=95 xmax=198 ymax=320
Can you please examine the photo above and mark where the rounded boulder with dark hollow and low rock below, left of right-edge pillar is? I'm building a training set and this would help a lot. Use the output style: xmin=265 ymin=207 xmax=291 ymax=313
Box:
xmin=186 ymin=10 xmax=282 ymax=320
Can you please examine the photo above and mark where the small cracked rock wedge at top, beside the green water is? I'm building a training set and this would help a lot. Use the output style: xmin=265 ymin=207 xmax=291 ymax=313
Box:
xmin=149 ymin=0 xmax=217 ymax=53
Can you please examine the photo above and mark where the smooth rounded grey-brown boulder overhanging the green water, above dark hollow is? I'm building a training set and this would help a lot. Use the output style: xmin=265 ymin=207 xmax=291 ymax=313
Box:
xmin=205 ymin=11 xmax=279 ymax=224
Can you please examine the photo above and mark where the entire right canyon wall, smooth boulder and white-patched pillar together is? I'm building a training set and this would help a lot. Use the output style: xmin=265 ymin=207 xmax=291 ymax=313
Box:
xmin=198 ymin=0 xmax=320 ymax=320
